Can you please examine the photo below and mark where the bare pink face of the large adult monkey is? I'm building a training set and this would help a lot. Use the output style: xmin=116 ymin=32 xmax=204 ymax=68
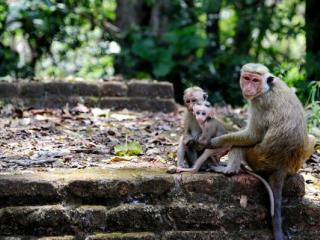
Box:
xmin=240 ymin=72 xmax=263 ymax=100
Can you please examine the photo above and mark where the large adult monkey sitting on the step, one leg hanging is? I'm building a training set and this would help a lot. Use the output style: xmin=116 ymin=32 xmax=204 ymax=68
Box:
xmin=207 ymin=63 xmax=315 ymax=240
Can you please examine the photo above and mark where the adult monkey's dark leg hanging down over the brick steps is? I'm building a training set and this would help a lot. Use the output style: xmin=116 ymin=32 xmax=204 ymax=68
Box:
xmin=269 ymin=169 xmax=286 ymax=240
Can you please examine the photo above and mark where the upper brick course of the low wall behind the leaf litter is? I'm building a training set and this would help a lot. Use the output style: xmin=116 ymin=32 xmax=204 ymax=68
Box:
xmin=0 ymin=80 xmax=174 ymax=99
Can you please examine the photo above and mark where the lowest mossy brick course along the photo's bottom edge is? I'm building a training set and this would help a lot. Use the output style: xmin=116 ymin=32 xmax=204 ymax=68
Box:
xmin=0 ymin=230 xmax=320 ymax=240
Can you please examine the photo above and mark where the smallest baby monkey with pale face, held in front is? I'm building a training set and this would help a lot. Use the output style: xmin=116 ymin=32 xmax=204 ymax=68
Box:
xmin=176 ymin=101 xmax=229 ymax=172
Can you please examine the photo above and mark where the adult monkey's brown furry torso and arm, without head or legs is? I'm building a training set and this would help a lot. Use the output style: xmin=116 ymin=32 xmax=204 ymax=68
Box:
xmin=213 ymin=79 xmax=313 ymax=175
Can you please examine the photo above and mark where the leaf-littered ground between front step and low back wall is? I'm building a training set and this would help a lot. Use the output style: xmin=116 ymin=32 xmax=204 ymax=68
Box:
xmin=0 ymin=105 xmax=320 ymax=202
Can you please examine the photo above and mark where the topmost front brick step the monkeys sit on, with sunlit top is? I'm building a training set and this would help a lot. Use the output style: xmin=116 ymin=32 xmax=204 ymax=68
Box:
xmin=0 ymin=169 xmax=288 ymax=207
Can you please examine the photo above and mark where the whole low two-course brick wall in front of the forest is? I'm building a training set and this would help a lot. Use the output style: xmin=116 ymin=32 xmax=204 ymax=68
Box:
xmin=0 ymin=80 xmax=176 ymax=112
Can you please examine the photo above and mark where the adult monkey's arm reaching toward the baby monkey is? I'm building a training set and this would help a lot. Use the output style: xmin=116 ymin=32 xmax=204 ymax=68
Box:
xmin=206 ymin=128 xmax=263 ymax=148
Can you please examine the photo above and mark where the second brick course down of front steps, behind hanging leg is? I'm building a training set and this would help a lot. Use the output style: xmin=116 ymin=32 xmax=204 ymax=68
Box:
xmin=0 ymin=202 xmax=320 ymax=236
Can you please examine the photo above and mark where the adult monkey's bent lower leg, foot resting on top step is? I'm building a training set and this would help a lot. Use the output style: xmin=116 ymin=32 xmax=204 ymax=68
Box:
xmin=212 ymin=147 xmax=245 ymax=174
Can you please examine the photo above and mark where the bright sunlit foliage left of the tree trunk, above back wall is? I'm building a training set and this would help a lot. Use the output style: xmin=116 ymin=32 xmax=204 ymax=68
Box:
xmin=0 ymin=0 xmax=115 ymax=78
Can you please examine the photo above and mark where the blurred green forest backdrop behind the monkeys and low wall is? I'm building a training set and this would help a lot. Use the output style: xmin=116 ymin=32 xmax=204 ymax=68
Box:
xmin=0 ymin=0 xmax=320 ymax=105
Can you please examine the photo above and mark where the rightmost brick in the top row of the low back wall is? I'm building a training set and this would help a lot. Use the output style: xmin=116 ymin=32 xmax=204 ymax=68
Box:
xmin=128 ymin=80 xmax=174 ymax=98
